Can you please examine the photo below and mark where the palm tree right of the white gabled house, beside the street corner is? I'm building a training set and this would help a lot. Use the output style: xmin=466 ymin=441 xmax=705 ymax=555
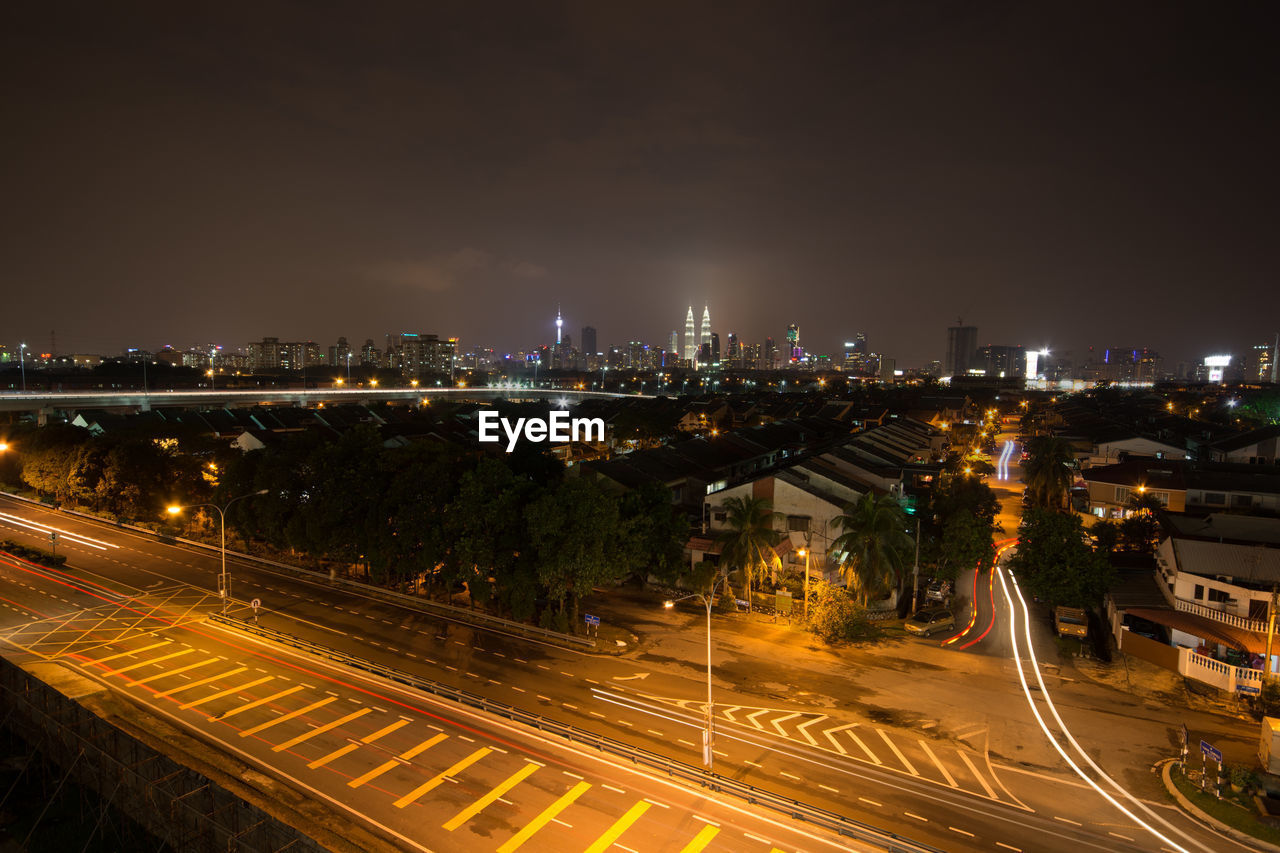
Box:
xmin=831 ymin=492 xmax=915 ymax=605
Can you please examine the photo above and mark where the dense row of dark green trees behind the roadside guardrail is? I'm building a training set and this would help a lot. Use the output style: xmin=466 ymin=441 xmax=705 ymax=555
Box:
xmin=218 ymin=428 xmax=689 ymax=630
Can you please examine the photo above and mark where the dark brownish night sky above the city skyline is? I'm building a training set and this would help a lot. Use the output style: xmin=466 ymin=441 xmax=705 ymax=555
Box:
xmin=0 ymin=0 xmax=1280 ymax=366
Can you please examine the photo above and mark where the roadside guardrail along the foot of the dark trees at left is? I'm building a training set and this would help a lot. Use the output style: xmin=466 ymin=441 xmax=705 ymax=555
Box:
xmin=0 ymin=492 xmax=596 ymax=649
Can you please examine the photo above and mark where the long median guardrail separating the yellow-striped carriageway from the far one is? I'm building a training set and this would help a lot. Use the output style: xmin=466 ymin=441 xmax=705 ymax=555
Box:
xmin=209 ymin=613 xmax=943 ymax=853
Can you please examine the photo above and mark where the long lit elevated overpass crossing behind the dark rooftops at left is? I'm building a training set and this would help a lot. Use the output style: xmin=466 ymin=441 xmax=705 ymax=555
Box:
xmin=0 ymin=386 xmax=653 ymax=415
